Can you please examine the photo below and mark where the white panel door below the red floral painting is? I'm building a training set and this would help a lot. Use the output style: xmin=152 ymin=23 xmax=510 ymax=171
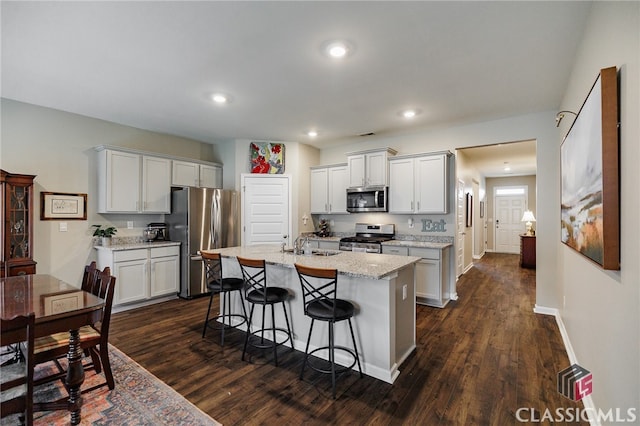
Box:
xmin=242 ymin=174 xmax=293 ymax=246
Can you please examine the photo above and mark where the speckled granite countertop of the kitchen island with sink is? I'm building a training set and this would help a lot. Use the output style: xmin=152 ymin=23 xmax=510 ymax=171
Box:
xmin=200 ymin=245 xmax=421 ymax=280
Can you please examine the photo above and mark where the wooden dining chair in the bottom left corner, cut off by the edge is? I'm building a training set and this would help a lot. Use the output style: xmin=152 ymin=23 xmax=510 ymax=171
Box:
xmin=0 ymin=313 xmax=35 ymax=426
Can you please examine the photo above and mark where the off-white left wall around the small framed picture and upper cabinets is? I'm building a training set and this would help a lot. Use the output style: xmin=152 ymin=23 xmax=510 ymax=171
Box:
xmin=0 ymin=99 xmax=214 ymax=285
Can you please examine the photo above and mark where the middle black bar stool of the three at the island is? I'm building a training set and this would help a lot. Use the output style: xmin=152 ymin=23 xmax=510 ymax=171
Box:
xmin=238 ymin=257 xmax=293 ymax=366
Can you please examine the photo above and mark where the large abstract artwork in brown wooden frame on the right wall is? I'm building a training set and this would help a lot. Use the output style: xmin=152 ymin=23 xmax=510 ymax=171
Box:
xmin=560 ymin=67 xmax=620 ymax=270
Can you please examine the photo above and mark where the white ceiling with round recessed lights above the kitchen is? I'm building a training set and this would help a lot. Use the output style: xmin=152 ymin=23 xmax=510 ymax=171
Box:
xmin=1 ymin=1 xmax=590 ymax=175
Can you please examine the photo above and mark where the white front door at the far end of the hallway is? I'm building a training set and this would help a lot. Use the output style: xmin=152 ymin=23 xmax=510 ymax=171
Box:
xmin=494 ymin=195 xmax=526 ymax=254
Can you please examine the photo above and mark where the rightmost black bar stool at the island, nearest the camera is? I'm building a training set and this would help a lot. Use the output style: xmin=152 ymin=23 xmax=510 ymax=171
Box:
xmin=295 ymin=263 xmax=362 ymax=399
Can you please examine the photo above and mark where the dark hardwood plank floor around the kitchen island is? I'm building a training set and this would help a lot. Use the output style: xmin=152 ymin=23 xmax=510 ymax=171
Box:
xmin=110 ymin=254 xmax=586 ymax=425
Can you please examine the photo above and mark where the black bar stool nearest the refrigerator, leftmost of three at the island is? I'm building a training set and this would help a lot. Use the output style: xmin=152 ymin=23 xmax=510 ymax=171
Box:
xmin=201 ymin=253 xmax=248 ymax=346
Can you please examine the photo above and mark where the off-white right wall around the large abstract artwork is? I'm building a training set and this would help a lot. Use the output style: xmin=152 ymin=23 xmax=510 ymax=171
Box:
xmin=556 ymin=2 xmax=640 ymax=418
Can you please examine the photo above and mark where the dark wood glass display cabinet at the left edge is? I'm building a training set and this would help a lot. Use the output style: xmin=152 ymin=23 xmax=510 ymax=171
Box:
xmin=0 ymin=170 xmax=36 ymax=277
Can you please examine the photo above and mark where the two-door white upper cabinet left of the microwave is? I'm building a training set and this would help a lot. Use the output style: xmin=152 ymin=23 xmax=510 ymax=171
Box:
xmin=310 ymin=164 xmax=347 ymax=214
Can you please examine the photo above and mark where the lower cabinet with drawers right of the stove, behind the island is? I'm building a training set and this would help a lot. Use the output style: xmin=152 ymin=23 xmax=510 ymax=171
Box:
xmin=382 ymin=245 xmax=451 ymax=308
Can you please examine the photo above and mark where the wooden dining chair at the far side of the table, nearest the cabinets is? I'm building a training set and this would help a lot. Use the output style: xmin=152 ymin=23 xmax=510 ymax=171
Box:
xmin=34 ymin=265 xmax=116 ymax=393
